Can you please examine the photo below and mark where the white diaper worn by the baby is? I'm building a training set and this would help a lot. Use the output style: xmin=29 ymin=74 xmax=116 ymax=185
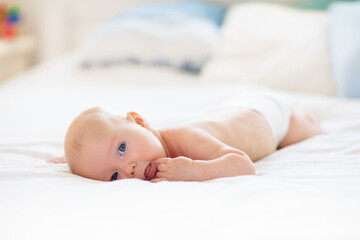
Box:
xmin=218 ymin=96 xmax=291 ymax=144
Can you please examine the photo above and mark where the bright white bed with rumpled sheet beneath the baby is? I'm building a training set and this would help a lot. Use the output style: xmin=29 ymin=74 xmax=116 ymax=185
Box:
xmin=0 ymin=0 xmax=360 ymax=239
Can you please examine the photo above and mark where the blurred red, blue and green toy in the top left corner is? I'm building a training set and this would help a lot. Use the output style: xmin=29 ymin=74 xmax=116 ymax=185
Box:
xmin=0 ymin=4 xmax=21 ymax=38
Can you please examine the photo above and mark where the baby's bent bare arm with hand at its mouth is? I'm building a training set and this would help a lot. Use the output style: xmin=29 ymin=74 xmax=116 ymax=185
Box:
xmin=152 ymin=146 xmax=255 ymax=182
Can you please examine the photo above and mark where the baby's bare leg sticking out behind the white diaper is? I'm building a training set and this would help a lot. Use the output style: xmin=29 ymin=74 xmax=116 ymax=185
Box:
xmin=278 ymin=108 xmax=322 ymax=148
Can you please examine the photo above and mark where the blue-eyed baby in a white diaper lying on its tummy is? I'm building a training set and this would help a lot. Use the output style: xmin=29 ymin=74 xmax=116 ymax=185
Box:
xmin=52 ymin=98 xmax=321 ymax=182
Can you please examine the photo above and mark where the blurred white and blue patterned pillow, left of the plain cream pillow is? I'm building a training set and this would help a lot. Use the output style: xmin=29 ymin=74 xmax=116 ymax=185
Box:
xmin=83 ymin=1 xmax=226 ymax=73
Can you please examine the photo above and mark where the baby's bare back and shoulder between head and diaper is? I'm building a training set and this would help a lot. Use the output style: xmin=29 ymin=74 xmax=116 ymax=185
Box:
xmin=163 ymin=107 xmax=276 ymax=161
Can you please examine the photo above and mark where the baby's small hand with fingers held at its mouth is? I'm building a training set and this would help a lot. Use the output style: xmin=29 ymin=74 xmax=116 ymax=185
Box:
xmin=151 ymin=157 xmax=194 ymax=182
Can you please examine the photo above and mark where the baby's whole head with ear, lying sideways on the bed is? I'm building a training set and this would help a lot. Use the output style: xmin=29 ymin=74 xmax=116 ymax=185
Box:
xmin=65 ymin=108 xmax=166 ymax=181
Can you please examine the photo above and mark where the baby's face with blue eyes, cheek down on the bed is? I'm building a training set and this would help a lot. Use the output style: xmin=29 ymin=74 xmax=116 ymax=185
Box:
xmin=74 ymin=111 xmax=166 ymax=181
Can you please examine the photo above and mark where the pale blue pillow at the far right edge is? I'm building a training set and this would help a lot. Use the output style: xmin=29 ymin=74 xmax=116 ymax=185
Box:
xmin=329 ymin=2 xmax=360 ymax=97
